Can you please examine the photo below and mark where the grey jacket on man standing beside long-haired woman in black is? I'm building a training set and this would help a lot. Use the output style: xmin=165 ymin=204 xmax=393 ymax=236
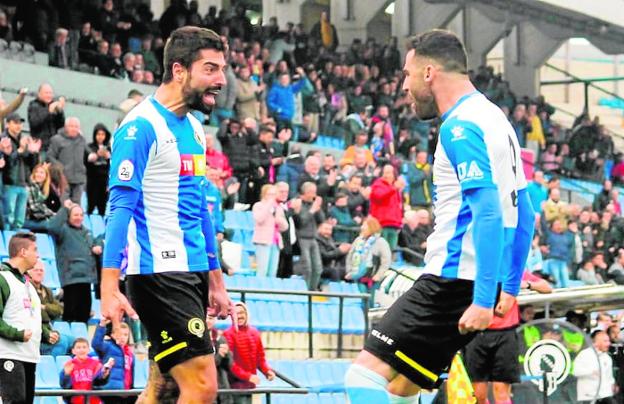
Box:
xmin=48 ymin=129 xmax=87 ymax=184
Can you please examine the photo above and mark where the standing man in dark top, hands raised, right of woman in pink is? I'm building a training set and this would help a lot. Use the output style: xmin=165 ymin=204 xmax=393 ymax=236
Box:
xmin=290 ymin=182 xmax=325 ymax=290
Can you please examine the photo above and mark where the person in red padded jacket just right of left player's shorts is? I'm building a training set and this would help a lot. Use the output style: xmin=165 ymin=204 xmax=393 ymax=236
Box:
xmin=223 ymin=302 xmax=275 ymax=404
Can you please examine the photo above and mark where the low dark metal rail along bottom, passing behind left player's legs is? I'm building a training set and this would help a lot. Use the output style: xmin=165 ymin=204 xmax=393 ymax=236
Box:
xmin=35 ymin=369 xmax=310 ymax=404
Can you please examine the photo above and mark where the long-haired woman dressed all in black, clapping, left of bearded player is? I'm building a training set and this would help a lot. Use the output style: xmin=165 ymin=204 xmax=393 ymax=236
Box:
xmin=86 ymin=123 xmax=111 ymax=216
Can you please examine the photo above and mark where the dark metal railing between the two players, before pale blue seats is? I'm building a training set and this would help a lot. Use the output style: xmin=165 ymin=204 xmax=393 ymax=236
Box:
xmin=228 ymin=288 xmax=370 ymax=358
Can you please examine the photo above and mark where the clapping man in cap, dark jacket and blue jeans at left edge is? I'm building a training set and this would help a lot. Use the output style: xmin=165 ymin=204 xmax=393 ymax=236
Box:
xmin=0 ymin=113 xmax=41 ymax=230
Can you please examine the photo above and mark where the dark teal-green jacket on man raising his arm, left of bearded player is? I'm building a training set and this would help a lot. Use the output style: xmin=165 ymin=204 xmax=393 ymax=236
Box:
xmin=48 ymin=208 xmax=101 ymax=286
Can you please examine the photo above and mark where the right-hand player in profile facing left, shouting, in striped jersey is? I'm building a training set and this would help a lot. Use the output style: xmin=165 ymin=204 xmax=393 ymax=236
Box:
xmin=345 ymin=30 xmax=534 ymax=404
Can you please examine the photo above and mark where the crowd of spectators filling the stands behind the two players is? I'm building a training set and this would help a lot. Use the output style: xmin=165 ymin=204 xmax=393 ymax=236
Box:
xmin=0 ymin=0 xmax=624 ymax=400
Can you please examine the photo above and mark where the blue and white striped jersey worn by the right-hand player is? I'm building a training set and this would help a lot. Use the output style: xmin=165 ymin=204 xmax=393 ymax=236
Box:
xmin=425 ymin=91 xmax=526 ymax=280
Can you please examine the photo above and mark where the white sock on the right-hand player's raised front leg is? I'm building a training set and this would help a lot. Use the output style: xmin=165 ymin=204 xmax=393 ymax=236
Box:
xmin=345 ymin=364 xmax=391 ymax=404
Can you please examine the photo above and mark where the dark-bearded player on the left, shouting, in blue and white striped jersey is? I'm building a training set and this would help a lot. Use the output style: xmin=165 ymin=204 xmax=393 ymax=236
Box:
xmin=101 ymin=27 xmax=233 ymax=403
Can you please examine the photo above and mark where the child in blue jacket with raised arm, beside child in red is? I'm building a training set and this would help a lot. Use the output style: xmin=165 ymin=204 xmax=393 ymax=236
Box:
xmin=91 ymin=319 xmax=136 ymax=403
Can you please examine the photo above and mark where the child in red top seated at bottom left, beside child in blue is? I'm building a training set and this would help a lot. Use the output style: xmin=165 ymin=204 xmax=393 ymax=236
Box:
xmin=60 ymin=338 xmax=115 ymax=404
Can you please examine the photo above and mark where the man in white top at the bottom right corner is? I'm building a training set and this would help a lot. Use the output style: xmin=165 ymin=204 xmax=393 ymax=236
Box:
xmin=574 ymin=330 xmax=617 ymax=404
